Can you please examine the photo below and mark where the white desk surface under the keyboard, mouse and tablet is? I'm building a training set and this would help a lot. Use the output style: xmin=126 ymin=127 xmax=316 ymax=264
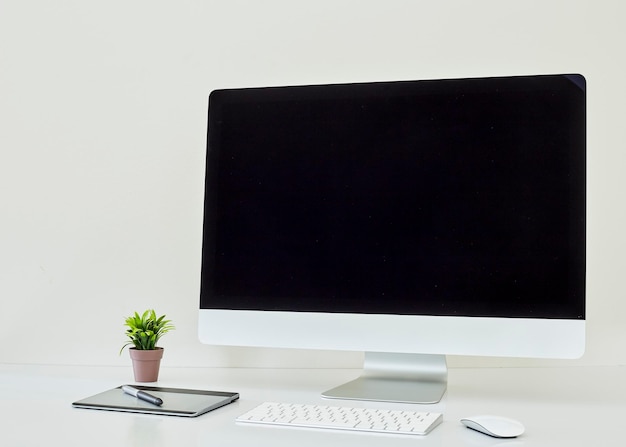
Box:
xmin=0 ymin=364 xmax=626 ymax=447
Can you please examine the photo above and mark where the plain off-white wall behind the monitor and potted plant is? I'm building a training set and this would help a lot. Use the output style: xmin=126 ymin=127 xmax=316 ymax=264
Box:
xmin=0 ymin=0 xmax=626 ymax=366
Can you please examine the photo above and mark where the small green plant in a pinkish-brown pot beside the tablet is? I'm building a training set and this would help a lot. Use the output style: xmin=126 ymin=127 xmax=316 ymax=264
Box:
xmin=120 ymin=309 xmax=174 ymax=382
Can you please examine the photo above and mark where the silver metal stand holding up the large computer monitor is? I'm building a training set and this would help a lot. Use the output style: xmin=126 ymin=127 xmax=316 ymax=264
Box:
xmin=322 ymin=352 xmax=448 ymax=404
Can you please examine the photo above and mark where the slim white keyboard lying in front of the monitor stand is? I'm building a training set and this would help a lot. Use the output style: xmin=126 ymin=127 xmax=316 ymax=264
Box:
xmin=237 ymin=402 xmax=443 ymax=435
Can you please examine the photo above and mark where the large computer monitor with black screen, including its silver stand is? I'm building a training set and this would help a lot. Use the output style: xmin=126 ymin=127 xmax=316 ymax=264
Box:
xmin=199 ymin=74 xmax=586 ymax=403
